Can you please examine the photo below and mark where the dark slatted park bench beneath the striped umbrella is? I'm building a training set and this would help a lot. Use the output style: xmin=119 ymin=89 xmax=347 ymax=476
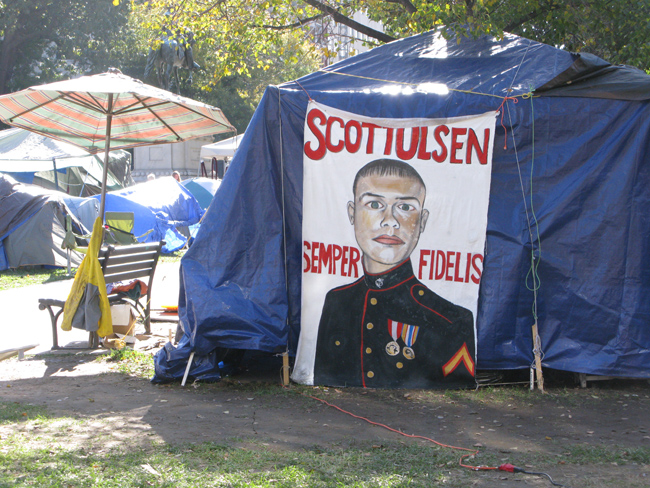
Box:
xmin=38 ymin=241 xmax=165 ymax=349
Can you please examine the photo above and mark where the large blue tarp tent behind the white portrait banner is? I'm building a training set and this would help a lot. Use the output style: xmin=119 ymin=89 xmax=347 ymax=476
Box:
xmin=154 ymin=31 xmax=650 ymax=381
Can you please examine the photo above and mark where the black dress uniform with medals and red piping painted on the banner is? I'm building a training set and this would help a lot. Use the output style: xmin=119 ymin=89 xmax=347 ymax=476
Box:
xmin=314 ymin=260 xmax=475 ymax=388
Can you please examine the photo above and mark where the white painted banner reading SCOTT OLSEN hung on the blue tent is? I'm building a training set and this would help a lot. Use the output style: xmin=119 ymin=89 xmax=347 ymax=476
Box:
xmin=292 ymin=102 xmax=496 ymax=388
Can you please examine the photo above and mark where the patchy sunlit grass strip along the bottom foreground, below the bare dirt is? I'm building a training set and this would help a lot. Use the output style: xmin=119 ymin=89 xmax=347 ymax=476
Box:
xmin=0 ymin=403 xmax=650 ymax=488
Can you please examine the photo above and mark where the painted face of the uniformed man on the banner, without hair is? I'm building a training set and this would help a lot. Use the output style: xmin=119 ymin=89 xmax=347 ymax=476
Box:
xmin=348 ymin=175 xmax=429 ymax=274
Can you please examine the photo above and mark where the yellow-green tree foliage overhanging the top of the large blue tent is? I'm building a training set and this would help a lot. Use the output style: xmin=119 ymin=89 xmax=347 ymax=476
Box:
xmin=134 ymin=0 xmax=650 ymax=79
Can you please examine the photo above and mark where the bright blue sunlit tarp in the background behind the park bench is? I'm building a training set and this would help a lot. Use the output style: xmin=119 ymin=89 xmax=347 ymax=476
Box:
xmin=92 ymin=177 xmax=204 ymax=253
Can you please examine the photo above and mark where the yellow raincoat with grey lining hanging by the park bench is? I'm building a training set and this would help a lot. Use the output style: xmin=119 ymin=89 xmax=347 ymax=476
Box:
xmin=61 ymin=217 xmax=113 ymax=337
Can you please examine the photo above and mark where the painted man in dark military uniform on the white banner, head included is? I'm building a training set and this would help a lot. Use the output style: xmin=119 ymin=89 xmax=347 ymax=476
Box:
xmin=314 ymin=159 xmax=475 ymax=388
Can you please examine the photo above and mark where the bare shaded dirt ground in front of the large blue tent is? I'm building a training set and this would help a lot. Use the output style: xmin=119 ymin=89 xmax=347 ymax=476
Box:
xmin=0 ymin=336 xmax=650 ymax=488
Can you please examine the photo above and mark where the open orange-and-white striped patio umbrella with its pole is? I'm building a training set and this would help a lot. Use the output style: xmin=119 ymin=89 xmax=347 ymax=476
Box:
xmin=0 ymin=68 xmax=235 ymax=216
